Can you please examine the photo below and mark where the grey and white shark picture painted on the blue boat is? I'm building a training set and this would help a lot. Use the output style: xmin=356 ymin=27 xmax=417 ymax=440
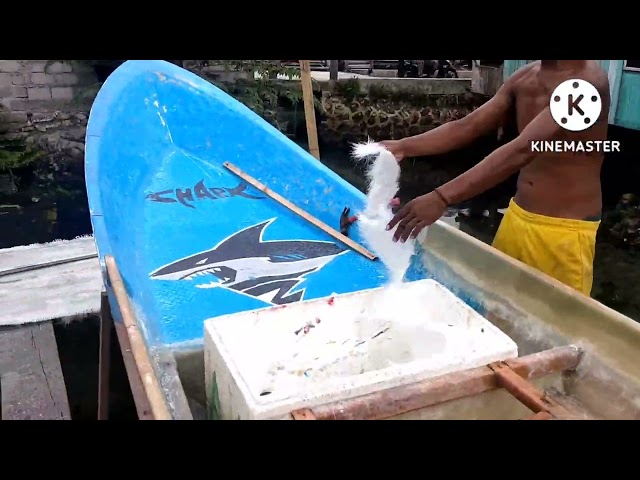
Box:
xmin=150 ymin=218 xmax=348 ymax=305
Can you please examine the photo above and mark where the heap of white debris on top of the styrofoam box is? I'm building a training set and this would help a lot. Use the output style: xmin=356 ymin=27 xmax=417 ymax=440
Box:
xmin=258 ymin=284 xmax=444 ymax=398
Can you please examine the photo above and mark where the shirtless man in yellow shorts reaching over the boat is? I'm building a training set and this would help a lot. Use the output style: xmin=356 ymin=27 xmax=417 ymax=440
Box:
xmin=382 ymin=60 xmax=610 ymax=295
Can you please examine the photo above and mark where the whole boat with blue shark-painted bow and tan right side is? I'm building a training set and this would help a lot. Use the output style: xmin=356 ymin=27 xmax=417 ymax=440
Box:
xmin=86 ymin=61 xmax=640 ymax=419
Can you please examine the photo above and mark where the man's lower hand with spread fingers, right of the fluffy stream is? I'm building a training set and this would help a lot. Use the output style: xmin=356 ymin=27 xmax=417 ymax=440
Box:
xmin=387 ymin=192 xmax=447 ymax=243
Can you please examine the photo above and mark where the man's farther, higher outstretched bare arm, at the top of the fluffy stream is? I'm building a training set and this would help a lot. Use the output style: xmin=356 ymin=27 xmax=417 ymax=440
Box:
xmin=397 ymin=64 xmax=533 ymax=157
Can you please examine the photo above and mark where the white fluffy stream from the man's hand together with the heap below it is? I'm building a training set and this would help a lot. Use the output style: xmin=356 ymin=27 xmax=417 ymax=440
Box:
xmin=259 ymin=142 xmax=430 ymax=392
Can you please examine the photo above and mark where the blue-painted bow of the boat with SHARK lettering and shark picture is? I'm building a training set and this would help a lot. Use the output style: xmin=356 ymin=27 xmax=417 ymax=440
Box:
xmin=85 ymin=60 xmax=423 ymax=350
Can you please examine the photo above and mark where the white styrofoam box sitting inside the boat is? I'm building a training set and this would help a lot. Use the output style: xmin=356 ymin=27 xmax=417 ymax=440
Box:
xmin=205 ymin=279 xmax=518 ymax=420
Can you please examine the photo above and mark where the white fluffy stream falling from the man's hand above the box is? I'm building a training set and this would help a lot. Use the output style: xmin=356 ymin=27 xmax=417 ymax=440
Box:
xmin=353 ymin=141 xmax=415 ymax=284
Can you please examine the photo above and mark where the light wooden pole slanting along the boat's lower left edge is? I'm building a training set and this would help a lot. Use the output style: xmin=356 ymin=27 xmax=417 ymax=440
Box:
xmin=104 ymin=255 xmax=172 ymax=420
